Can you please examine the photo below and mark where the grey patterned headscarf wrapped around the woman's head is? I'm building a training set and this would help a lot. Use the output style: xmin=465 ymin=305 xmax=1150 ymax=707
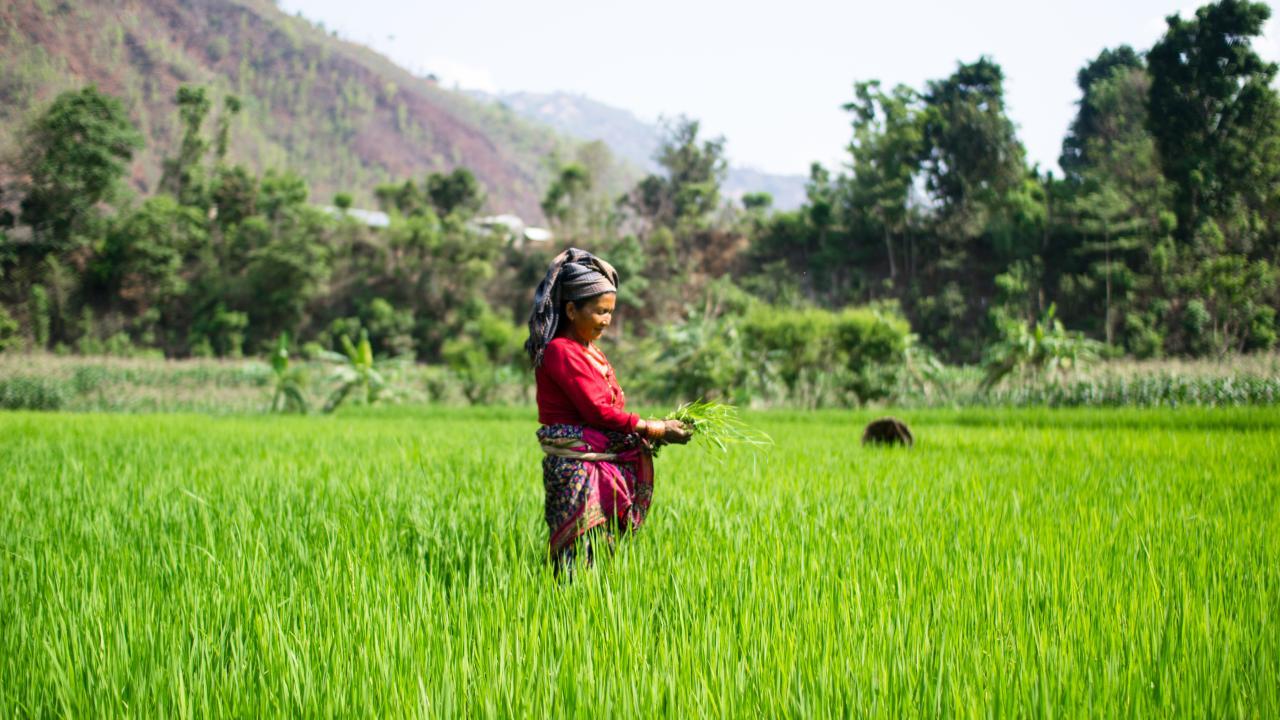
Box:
xmin=525 ymin=247 xmax=618 ymax=369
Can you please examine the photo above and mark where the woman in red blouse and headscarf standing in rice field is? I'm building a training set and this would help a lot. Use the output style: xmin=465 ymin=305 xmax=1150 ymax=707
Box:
xmin=525 ymin=247 xmax=690 ymax=570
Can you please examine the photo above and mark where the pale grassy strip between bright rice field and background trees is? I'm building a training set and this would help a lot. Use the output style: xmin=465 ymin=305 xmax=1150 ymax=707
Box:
xmin=0 ymin=354 xmax=1280 ymax=415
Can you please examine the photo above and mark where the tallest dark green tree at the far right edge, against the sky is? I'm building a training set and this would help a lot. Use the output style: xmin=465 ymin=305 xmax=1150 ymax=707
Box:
xmin=1147 ymin=0 xmax=1280 ymax=252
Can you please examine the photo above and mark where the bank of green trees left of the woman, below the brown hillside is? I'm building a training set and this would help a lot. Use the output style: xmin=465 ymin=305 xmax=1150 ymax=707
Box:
xmin=0 ymin=79 xmax=555 ymax=359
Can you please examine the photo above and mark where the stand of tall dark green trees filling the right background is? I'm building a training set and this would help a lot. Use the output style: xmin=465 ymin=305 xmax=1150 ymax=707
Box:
xmin=750 ymin=0 xmax=1280 ymax=361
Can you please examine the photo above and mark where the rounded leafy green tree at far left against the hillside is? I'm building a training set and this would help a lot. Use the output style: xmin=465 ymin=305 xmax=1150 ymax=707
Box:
xmin=22 ymin=86 xmax=142 ymax=251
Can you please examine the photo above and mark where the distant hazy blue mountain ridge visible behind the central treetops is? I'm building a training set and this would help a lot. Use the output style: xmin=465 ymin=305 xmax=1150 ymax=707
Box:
xmin=474 ymin=92 xmax=808 ymax=210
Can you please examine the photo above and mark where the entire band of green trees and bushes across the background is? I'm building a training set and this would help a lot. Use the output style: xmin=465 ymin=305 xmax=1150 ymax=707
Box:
xmin=0 ymin=0 xmax=1280 ymax=392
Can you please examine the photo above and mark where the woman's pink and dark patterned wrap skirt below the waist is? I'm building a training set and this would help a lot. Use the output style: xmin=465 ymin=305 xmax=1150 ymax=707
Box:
xmin=538 ymin=425 xmax=653 ymax=559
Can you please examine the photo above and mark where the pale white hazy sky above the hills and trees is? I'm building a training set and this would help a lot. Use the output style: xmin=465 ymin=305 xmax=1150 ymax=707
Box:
xmin=280 ymin=0 xmax=1280 ymax=173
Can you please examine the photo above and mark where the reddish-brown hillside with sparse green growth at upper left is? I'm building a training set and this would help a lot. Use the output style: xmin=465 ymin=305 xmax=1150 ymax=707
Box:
xmin=0 ymin=0 xmax=581 ymax=218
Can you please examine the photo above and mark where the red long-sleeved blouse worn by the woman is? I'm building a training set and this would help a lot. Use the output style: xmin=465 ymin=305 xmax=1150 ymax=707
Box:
xmin=534 ymin=337 xmax=640 ymax=433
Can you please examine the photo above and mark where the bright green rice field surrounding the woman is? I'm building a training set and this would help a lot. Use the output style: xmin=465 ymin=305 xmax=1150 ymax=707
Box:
xmin=0 ymin=407 xmax=1280 ymax=717
